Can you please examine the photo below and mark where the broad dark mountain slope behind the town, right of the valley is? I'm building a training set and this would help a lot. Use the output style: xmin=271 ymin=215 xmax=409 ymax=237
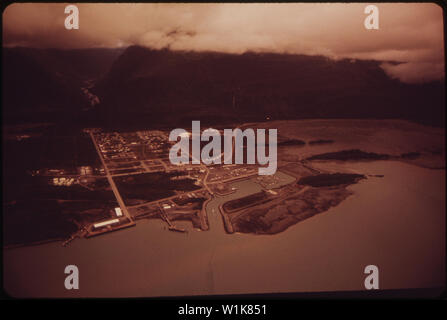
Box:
xmin=94 ymin=46 xmax=445 ymax=126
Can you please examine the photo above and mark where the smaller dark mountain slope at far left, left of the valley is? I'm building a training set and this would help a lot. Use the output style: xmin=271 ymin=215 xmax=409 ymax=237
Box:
xmin=2 ymin=47 xmax=126 ymax=122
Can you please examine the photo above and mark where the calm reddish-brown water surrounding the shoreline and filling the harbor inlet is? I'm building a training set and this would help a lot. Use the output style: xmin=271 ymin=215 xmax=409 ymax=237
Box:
xmin=3 ymin=161 xmax=445 ymax=297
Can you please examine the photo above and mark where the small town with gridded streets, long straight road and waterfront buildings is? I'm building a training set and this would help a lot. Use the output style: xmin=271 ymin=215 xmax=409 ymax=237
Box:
xmin=28 ymin=128 xmax=270 ymax=246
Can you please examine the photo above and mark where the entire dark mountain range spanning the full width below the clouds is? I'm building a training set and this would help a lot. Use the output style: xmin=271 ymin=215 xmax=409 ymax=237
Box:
xmin=2 ymin=46 xmax=445 ymax=130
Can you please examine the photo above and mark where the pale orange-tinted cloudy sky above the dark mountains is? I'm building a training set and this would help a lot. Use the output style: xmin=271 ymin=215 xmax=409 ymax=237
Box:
xmin=3 ymin=3 xmax=444 ymax=82
